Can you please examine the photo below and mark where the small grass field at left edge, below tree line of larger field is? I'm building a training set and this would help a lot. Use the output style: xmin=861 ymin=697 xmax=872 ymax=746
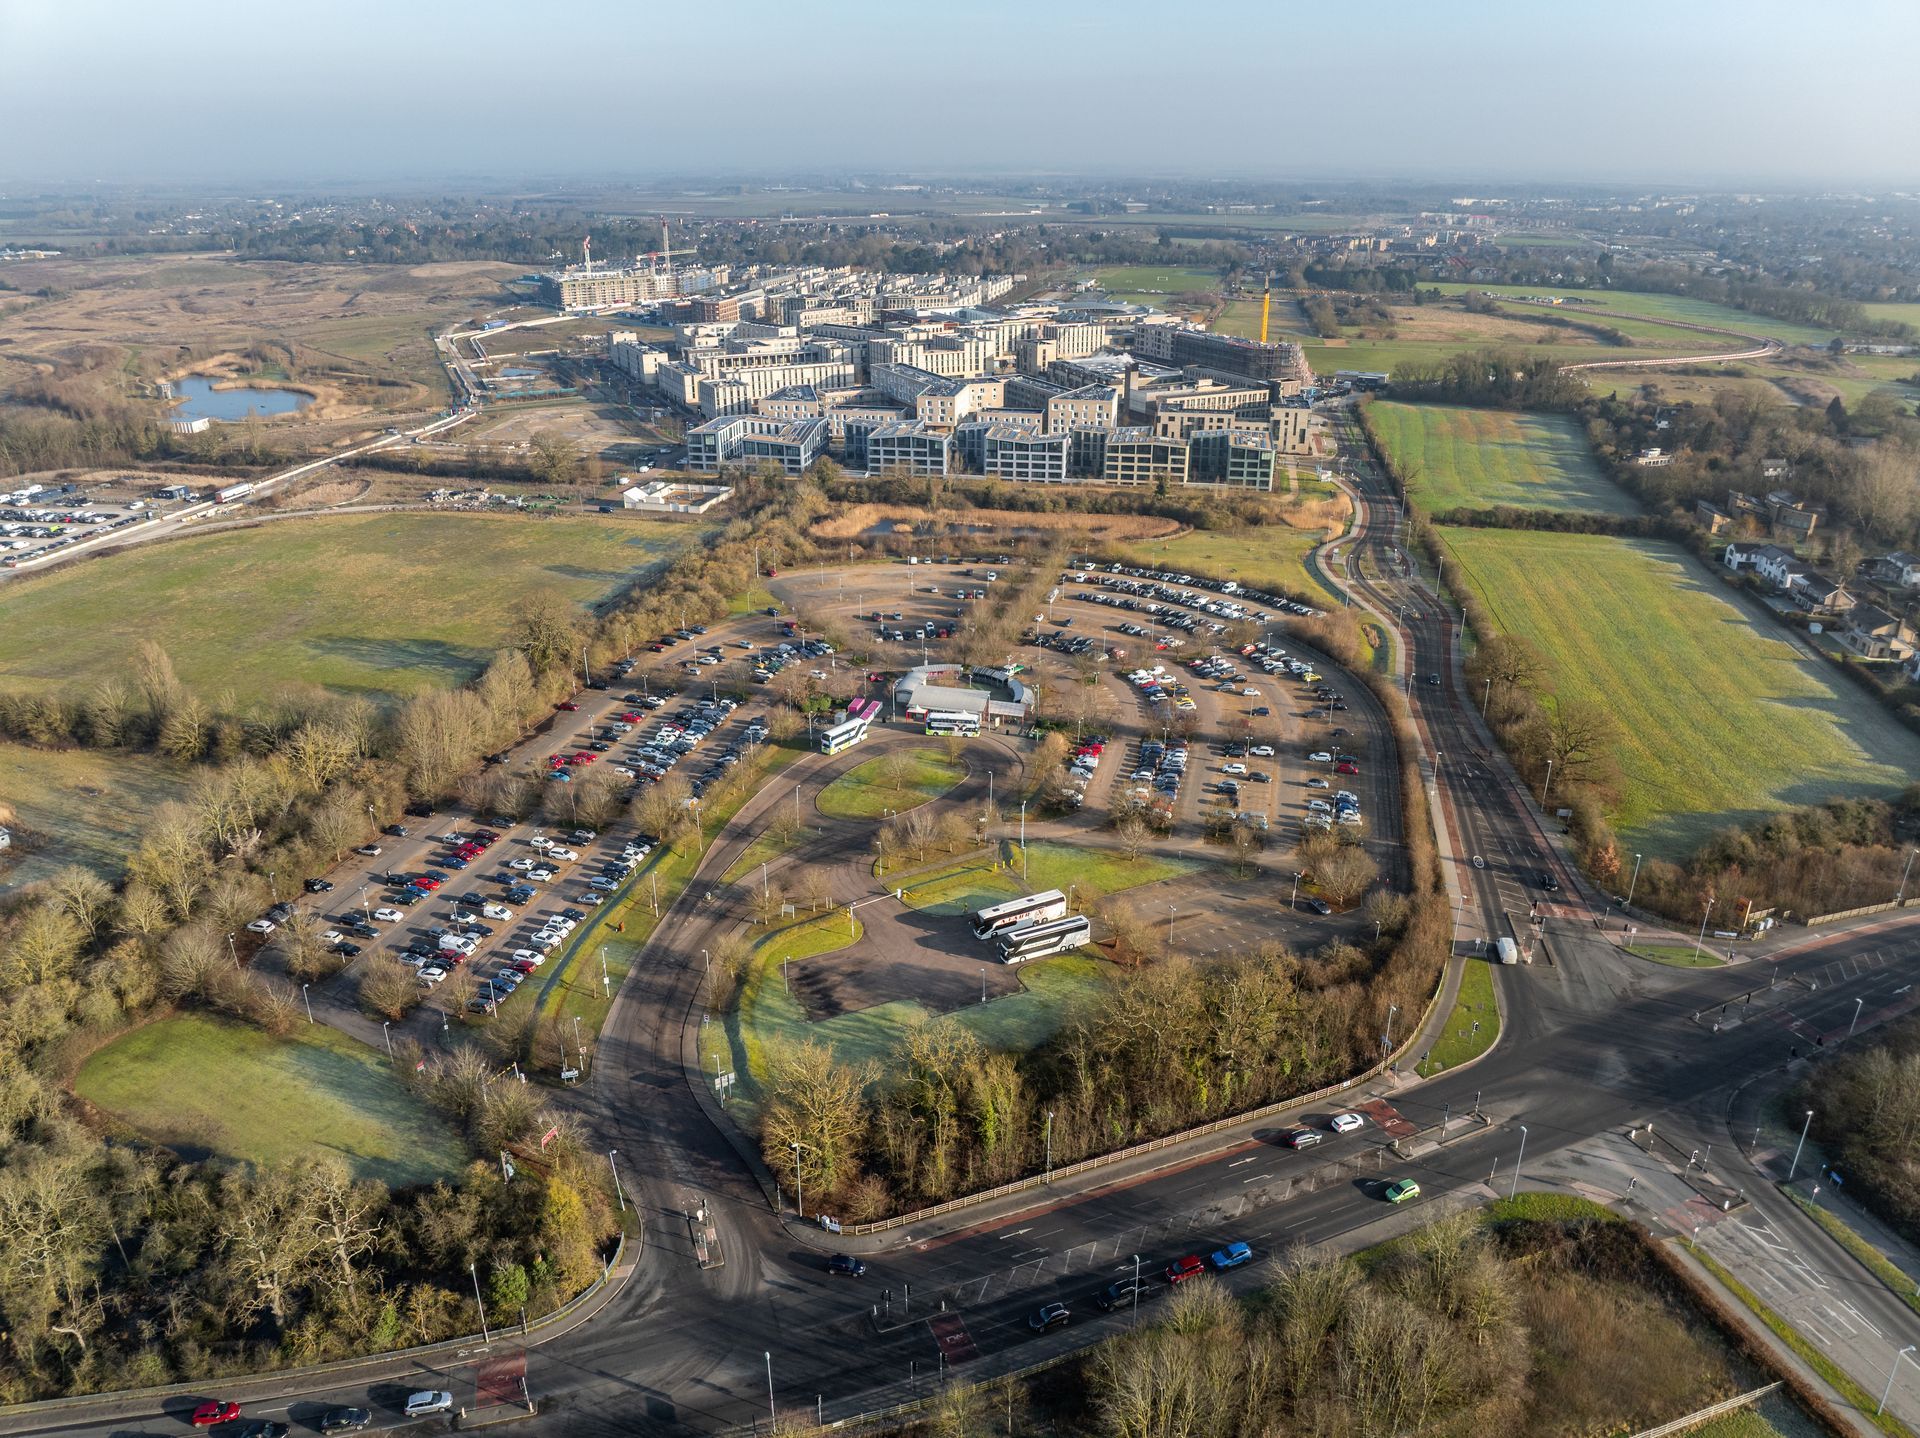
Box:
xmin=0 ymin=743 xmax=188 ymax=895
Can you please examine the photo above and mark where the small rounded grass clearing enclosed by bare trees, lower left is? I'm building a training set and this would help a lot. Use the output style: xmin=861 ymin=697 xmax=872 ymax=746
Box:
xmin=73 ymin=1014 xmax=467 ymax=1186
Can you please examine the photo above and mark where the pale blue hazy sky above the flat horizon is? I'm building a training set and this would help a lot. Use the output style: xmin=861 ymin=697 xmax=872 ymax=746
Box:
xmin=0 ymin=0 xmax=1920 ymax=186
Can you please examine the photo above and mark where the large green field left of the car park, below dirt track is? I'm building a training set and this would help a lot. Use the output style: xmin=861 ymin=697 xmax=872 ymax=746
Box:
xmin=0 ymin=515 xmax=705 ymax=699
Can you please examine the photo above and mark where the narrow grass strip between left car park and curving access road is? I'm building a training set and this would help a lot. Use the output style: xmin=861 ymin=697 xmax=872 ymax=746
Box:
xmin=538 ymin=745 xmax=804 ymax=1035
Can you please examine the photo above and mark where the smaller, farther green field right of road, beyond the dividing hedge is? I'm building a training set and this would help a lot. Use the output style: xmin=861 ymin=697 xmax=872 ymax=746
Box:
xmin=1367 ymin=399 xmax=1640 ymax=515
